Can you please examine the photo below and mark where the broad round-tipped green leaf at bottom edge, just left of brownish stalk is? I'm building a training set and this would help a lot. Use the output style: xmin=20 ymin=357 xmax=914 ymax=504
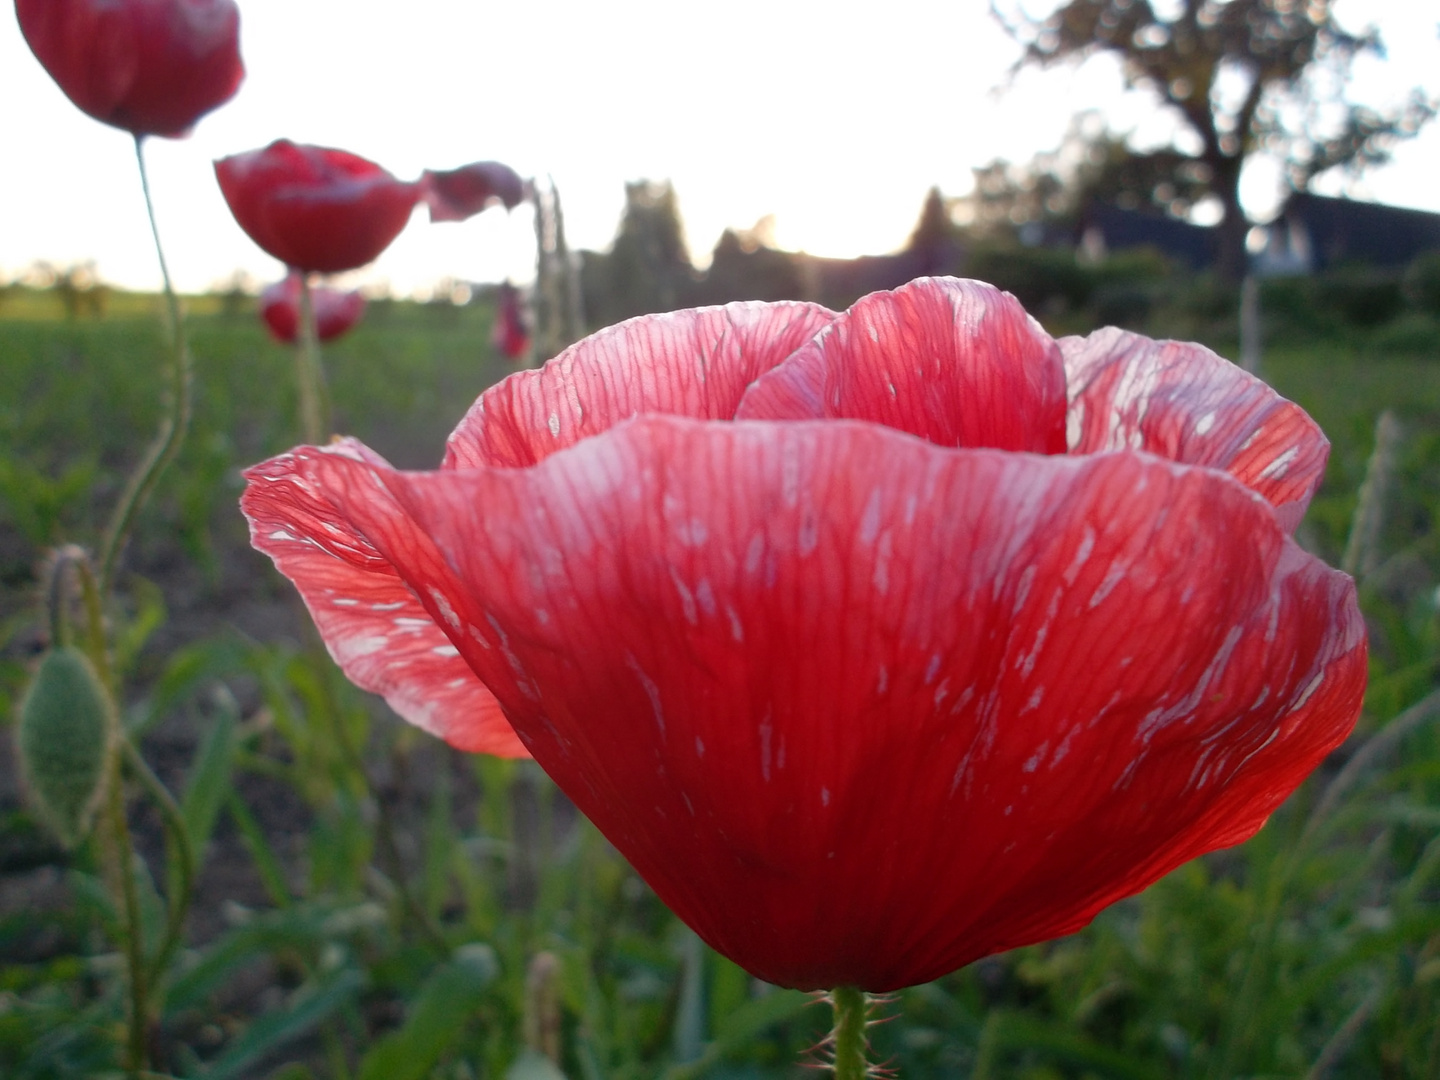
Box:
xmin=360 ymin=945 xmax=498 ymax=1080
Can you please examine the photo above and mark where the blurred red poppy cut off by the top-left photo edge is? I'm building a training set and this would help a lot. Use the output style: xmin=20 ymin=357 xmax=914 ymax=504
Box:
xmin=14 ymin=0 xmax=245 ymax=135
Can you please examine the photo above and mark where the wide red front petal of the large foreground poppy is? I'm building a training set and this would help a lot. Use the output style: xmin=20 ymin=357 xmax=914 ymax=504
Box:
xmin=307 ymin=416 xmax=1365 ymax=991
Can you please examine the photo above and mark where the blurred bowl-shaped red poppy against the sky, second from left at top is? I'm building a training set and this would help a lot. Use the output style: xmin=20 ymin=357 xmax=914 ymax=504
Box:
xmin=215 ymin=138 xmax=419 ymax=274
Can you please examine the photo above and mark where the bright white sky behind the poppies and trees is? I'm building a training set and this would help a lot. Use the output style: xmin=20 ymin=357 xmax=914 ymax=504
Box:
xmin=0 ymin=0 xmax=1440 ymax=292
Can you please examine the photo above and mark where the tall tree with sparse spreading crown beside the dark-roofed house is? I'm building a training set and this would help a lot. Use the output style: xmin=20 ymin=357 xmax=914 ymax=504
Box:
xmin=991 ymin=0 xmax=1437 ymax=279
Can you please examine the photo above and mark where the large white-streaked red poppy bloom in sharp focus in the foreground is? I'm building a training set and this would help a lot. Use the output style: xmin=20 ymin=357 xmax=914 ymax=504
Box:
xmin=243 ymin=279 xmax=1365 ymax=991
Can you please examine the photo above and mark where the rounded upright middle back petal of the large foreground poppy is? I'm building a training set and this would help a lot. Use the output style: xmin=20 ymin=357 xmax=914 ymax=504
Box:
xmin=736 ymin=278 xmax=1066 ymax=454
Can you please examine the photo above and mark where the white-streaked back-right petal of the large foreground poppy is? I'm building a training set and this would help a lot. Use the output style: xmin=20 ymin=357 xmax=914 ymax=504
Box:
xmin=1060 ymin=327 xmax=1331 ymax=533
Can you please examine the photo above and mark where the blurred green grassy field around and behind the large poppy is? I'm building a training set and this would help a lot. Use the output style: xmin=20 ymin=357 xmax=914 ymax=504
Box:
xmin=0 ymin=291 xmax=1440 ymax=1080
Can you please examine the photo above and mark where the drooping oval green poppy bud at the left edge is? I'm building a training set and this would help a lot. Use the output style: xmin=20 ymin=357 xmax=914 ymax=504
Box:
xmin=19 ymin=645 xmax=111 ymax=847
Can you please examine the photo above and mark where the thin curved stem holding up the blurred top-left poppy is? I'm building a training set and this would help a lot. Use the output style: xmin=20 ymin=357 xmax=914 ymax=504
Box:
xmin=99 ymin=135 xmax=193 ymax=596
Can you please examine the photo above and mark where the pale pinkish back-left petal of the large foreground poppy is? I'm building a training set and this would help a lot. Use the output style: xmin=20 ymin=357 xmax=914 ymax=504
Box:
xmin=441 ymin=302 xmax=835 ymax=468
